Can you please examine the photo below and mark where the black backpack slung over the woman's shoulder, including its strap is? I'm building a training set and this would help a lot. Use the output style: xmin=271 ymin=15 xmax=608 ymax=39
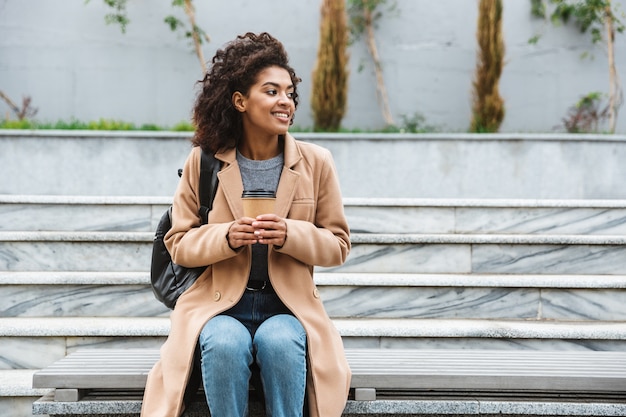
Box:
xmin=150 ymin=151 xmax=220 ymax=309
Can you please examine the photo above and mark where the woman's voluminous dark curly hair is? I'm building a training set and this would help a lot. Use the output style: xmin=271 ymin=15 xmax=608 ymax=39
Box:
xmin=192 ymin=32 xmax=301 ymax=152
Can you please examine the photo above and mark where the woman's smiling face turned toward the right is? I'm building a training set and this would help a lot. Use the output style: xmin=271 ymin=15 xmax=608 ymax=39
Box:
xmin=233 ymin=66 xmax=296 ymax=140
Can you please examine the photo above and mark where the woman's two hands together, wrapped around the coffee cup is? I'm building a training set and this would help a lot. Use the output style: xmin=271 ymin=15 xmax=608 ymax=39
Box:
xmin=226 ymin=214 xmax=287 ymax=249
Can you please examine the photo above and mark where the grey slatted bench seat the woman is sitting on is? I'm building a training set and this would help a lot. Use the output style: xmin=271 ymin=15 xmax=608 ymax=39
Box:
xmin=33 ymin=349 xmax=626 ymax=392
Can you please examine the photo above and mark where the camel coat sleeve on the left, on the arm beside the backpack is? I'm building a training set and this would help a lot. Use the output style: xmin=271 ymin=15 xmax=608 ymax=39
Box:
xmin=164 ymin=147 xmax=237 ymax=268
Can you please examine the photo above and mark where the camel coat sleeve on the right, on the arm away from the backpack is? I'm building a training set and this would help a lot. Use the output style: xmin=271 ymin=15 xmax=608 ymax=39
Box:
xmin=276 ymin=150 xmax=350 ymax=267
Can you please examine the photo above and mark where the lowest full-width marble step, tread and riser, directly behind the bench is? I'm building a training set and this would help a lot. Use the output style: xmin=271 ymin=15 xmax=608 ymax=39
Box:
xmin=0 ymin=317 xmax=626 ymax=370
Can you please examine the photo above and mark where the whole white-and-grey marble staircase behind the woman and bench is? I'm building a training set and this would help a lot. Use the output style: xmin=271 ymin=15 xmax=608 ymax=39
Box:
xmin=0 ymin=195 xmax=626 ymax=417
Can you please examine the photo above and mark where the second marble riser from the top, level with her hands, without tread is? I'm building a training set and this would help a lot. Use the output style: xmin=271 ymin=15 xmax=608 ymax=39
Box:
xmin=0 ymin=242 xmax=626 ymax=275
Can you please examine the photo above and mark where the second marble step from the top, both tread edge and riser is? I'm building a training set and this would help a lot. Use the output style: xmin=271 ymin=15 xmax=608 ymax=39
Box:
xmin=0 ymin=231 xmax=626 ymax=275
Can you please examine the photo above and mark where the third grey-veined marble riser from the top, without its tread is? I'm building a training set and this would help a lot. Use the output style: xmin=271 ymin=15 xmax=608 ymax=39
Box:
xmin=0 ymin=285 xmax=626 ymax=321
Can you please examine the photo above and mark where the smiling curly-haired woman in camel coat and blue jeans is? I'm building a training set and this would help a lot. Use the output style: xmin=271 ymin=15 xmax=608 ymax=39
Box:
xmin=142 ymin=33 xmax=350 ymax=417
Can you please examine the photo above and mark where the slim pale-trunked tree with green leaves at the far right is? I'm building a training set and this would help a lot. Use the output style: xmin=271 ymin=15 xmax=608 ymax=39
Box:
xmin=531 ymin=0 xmax=626 ymax=133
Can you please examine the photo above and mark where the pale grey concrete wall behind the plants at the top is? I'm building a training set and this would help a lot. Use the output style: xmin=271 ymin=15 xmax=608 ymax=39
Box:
xmin=0 ymin=0 xmax=626 ymax=133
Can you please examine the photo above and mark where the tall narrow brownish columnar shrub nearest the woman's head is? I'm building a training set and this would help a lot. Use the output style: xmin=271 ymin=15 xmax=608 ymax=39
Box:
xmin=311 ymin=0 xmax=348 ymax=131
